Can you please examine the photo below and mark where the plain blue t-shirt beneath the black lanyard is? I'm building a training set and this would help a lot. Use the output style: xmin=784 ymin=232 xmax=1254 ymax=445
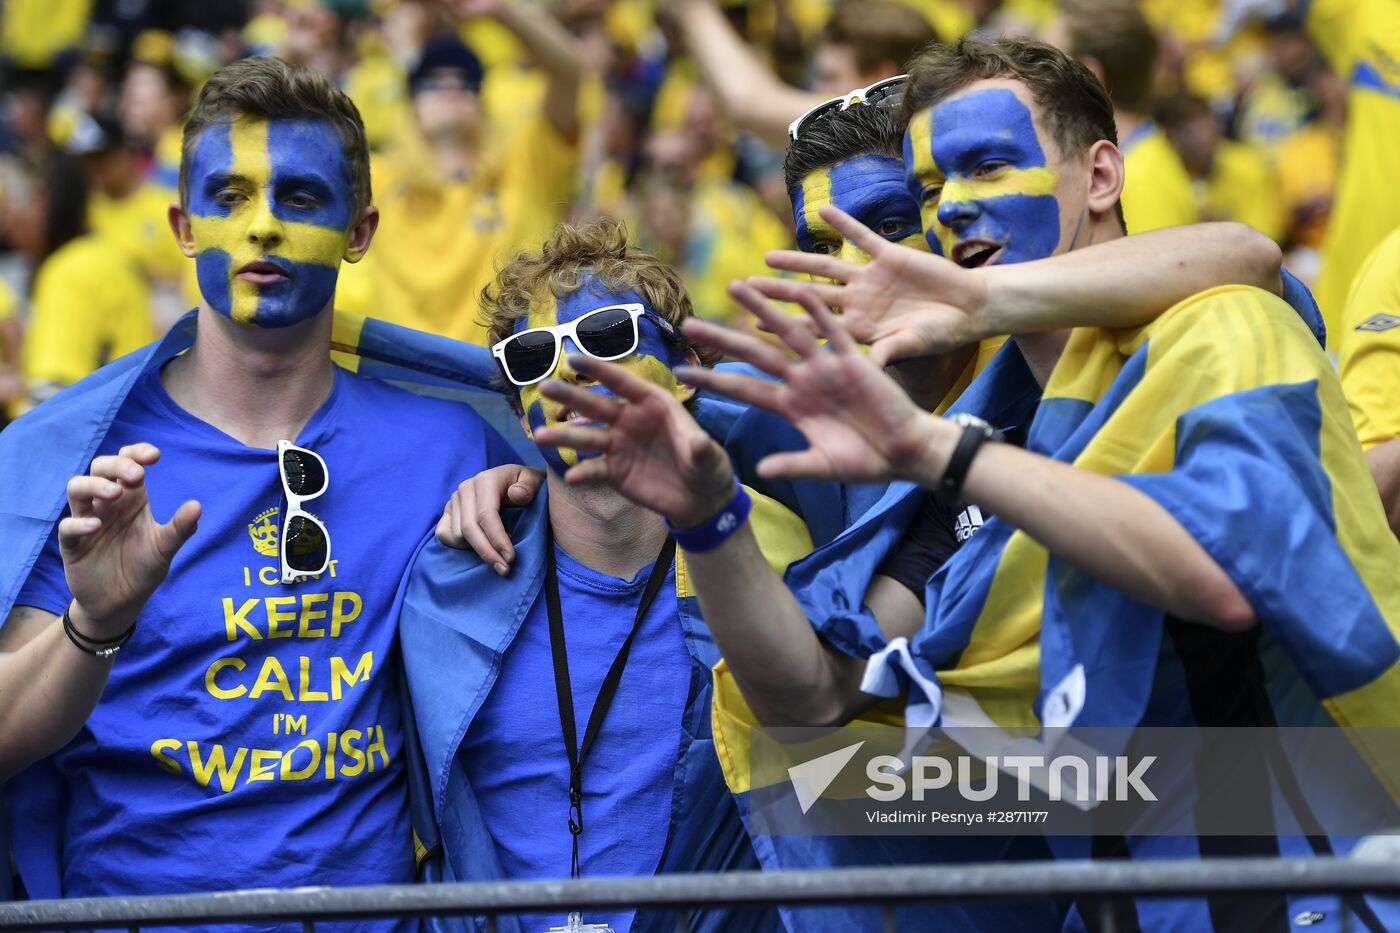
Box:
xmin=458 ymin=546 xmax=693 ymax=933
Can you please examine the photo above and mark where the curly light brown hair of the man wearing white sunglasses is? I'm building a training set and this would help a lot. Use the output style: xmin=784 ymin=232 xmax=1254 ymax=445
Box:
xmin=482 ymin=217 xmax=720 ymax=366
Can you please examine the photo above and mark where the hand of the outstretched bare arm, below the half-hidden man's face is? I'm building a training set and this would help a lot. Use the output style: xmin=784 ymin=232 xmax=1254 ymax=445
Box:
xmin=750 ymin=205 xmax=998 ymax=366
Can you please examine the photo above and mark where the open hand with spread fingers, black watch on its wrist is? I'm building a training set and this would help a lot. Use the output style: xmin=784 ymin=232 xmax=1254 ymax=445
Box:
xmin=676 ymin=282 xmax=942 ymax=482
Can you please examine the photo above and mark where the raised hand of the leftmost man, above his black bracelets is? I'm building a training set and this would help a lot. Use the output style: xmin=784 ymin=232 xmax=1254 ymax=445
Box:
xmin=59 ymin=444 xmax=200 ymax=639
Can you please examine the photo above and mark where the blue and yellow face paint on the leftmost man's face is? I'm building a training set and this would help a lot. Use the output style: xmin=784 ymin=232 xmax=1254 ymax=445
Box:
xmin=189 ymin=118 xmax=358 ymax=328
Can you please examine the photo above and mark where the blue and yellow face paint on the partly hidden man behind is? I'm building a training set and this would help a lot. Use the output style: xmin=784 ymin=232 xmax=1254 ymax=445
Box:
xmin=791 ymin=156 xmax=938 ymax=265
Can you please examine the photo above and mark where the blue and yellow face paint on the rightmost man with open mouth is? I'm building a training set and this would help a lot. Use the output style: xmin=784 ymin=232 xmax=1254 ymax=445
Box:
xmin=904 ymin=87 xmax=1061 ymax=262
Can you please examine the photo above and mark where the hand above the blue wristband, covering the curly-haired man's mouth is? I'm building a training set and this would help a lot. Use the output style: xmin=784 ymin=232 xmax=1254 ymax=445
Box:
xmin=535 ymin=364 xmax=734 ymax=528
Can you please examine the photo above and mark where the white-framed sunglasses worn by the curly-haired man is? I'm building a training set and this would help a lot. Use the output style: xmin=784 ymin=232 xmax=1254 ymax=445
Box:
xmin=491 ymin=304 xmax=680 ymax=388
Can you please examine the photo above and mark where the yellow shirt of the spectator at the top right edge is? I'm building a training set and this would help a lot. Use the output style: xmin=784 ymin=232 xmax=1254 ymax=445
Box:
xmin=1308 ymin=0 xmax=1400 ymax=340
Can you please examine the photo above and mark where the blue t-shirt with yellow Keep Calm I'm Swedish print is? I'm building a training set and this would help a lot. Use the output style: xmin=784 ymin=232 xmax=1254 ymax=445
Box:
xmin=10 ymin=367 xmax=515 ymax=929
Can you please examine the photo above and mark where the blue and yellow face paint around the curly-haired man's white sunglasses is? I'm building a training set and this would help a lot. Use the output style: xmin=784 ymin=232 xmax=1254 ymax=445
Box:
xmin=515 ymin=272 xmax=694 ymax=475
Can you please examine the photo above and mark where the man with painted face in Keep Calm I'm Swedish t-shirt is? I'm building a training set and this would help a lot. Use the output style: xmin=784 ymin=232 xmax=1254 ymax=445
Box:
xmin=0 ymin=57 xmax=514 ymax=913
